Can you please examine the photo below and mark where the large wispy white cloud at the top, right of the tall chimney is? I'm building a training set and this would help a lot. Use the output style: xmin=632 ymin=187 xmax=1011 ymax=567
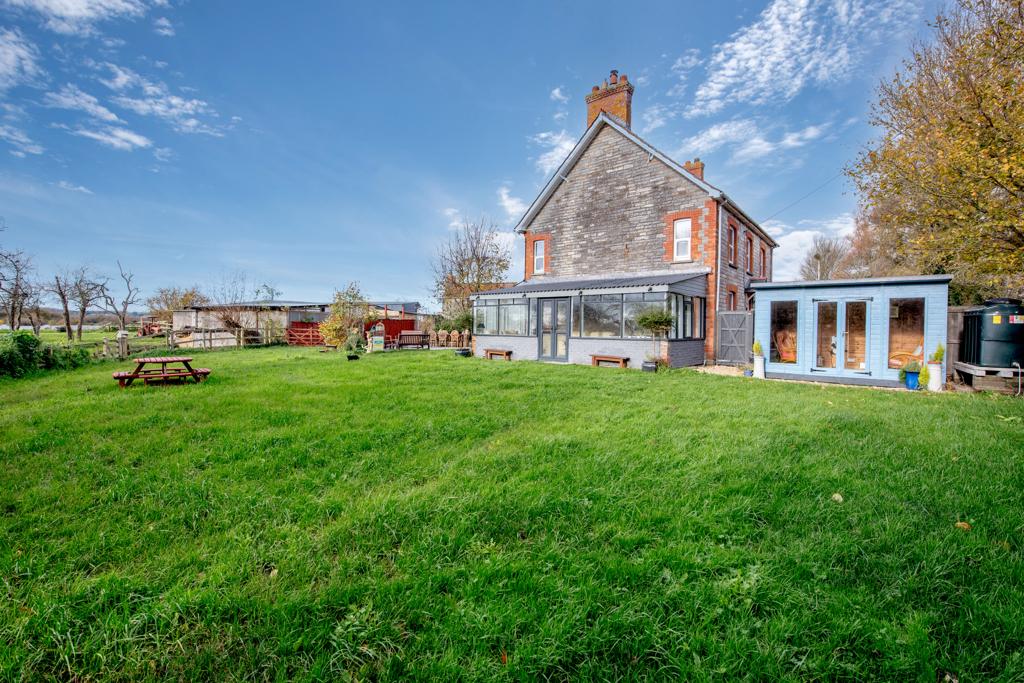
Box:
xmin=687 ymin=0 xmax=921 ymax=117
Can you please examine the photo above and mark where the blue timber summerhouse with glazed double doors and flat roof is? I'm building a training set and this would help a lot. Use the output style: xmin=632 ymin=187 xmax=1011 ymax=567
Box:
xmin=751 ymin=275 xmax=952 ymax=386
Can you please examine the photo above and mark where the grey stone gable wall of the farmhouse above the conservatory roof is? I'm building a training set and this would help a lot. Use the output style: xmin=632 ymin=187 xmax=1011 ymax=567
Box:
xmin=526 ymin=126 xmax=717 ymax=279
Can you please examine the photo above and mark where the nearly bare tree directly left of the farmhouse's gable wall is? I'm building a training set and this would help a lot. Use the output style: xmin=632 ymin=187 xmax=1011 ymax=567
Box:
xmin=432 ymin=217 xmax=511 ymax=316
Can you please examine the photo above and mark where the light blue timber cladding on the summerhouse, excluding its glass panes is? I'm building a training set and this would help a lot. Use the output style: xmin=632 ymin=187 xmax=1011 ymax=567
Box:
xmin=754 ymin=281 xmax=949 ymax=385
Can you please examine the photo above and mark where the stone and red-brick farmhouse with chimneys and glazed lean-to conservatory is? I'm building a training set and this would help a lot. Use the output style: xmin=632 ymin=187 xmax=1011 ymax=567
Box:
xmin=473 ymin=71 xmax=777 ymax=368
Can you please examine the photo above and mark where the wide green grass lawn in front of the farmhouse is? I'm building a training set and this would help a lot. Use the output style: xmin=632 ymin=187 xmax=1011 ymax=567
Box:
xmin=0 ymin=348 xmax=1024 ymax=683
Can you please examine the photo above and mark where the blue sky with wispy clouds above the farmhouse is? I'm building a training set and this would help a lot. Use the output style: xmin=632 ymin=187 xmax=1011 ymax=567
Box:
xmin=0 ymin=0 xmax=935 ymax=306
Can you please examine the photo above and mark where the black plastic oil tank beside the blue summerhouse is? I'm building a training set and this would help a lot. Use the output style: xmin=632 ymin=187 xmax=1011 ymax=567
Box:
xmin=959 ymin=299 xmax=1024 ymax=368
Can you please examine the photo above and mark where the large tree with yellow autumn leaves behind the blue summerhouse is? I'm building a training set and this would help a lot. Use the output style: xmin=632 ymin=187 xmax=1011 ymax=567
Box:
xmin=849 ymin=0 xmax=1024 ymax=293
